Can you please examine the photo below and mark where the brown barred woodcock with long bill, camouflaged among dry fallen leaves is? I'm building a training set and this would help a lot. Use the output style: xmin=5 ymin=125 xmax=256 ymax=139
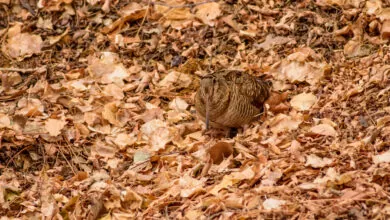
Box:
xmin=195 ymin=71 xmax=270 ymax=129
